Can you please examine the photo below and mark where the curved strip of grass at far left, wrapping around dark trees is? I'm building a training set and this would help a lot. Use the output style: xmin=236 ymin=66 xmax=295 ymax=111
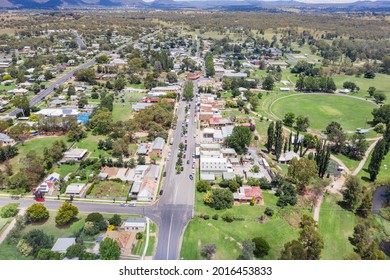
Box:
xmin=11 ymin=136 xmax=69 ymax=174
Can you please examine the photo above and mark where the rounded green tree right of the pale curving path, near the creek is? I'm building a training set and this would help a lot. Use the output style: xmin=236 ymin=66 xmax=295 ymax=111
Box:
xmin=343 ymin=176 xmax=363 ymax=211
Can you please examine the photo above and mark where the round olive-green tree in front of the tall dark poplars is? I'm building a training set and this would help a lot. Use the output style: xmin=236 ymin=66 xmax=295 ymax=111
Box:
xmin=288 ymin=158 xmax=318 ymax=190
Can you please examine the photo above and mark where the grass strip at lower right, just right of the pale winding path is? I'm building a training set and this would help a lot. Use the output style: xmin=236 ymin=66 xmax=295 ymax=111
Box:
xmin=318 ymin=195 xmax=356 ymax=260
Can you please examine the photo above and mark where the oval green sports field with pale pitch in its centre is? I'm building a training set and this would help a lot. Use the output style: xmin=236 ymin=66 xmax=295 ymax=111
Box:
xmin=270 ymin=95 xmax=376 ymax=131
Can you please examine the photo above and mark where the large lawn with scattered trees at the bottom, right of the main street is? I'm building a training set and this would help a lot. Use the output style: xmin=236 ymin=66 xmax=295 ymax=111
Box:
xmin=181 ymin=191 xmax=299 ymax=260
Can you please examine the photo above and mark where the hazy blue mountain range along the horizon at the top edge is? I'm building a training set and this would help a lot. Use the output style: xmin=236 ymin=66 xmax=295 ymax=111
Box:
xmin=0 ymin=0 xmax=390 ymax=12
